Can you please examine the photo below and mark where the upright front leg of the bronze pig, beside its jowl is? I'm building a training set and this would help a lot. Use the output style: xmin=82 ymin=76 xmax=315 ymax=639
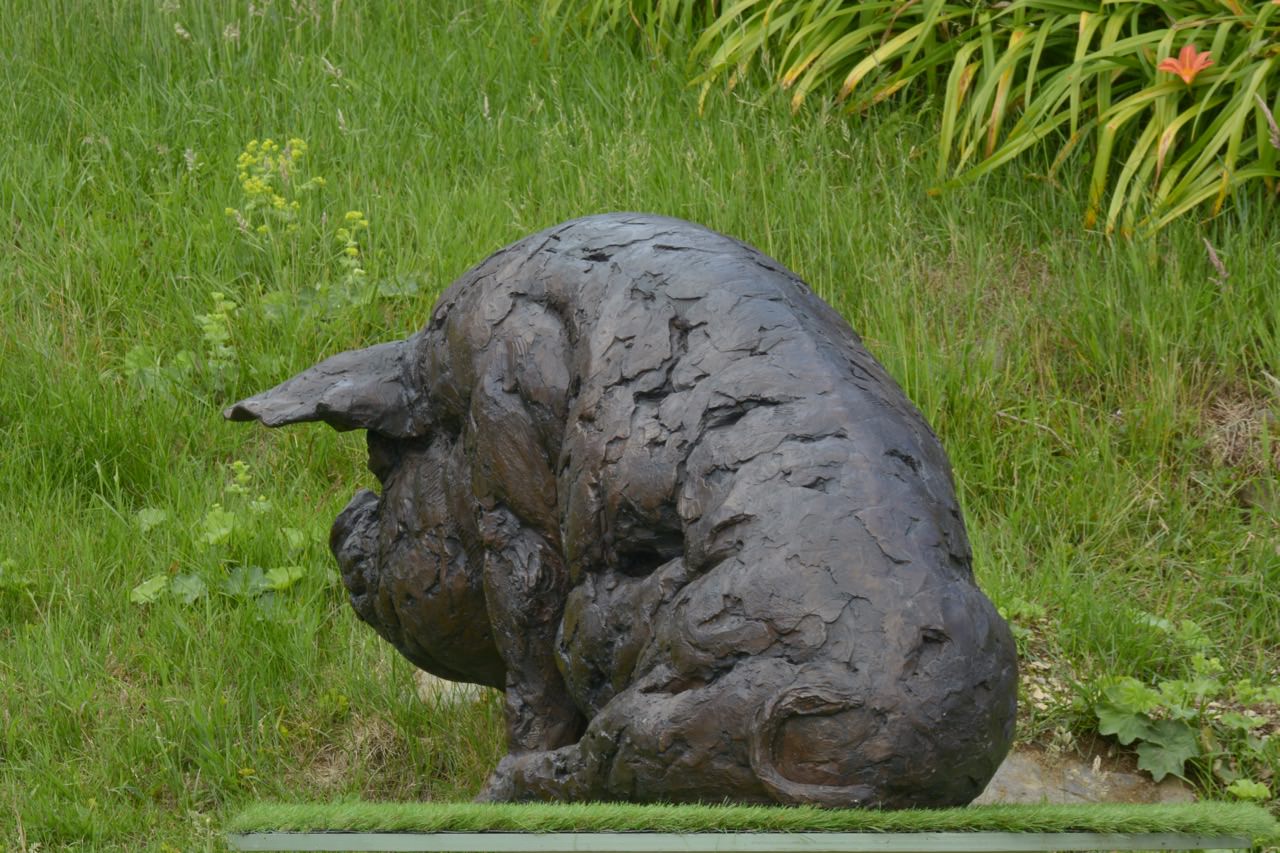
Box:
xmin=481 ymin=507 xmax=585 ymax=754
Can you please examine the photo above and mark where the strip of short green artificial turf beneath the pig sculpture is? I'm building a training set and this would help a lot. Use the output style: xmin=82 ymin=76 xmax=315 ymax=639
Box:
xmin=228 ymin=800 xmax=1277 ymax=838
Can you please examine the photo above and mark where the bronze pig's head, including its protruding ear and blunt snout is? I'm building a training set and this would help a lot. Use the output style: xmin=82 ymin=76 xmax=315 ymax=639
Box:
xmin=223 ymin=338 xmax=502 ymax=684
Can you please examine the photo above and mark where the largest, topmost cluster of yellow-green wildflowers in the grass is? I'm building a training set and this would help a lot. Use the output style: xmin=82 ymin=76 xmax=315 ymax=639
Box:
xmin=225 ymin=137 xmax=324 ymax=234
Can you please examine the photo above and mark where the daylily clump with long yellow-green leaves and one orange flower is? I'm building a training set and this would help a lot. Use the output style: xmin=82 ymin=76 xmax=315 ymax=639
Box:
xmin=578 ymin=0 xmax=1280 ymax=236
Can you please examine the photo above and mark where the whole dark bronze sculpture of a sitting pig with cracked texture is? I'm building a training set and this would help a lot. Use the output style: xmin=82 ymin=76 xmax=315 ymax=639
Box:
xmin=225 ymin=214 xmax=1016 ymax=808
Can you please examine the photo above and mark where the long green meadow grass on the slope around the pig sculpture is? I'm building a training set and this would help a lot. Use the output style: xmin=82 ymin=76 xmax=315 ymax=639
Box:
xmin=0 ymin=0 xmax=1280 ymax=849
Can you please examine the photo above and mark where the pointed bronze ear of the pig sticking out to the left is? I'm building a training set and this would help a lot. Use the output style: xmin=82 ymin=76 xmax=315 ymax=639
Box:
xmin=223 ymin=338 xmax=425 ymax=438
